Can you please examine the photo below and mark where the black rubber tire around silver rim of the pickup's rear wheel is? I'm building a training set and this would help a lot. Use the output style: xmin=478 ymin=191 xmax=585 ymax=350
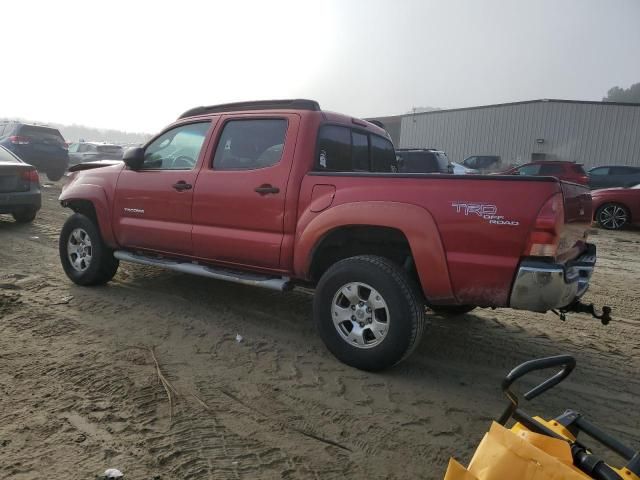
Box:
xmin=313 ymin=255 xmax=425 ymax=371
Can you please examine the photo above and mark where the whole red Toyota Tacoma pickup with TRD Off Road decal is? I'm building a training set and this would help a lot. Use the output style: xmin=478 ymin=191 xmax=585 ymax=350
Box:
xmin=60 ymin=100 xmax=596 ymax=370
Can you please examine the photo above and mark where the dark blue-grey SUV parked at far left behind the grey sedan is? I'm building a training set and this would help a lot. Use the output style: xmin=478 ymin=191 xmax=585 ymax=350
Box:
xmin=0 ymin=121 xmax=69 ymax=181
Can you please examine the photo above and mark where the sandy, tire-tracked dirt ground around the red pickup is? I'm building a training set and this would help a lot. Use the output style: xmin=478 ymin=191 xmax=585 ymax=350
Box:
xmin=0 ymin=178 xmax=640 ymax=480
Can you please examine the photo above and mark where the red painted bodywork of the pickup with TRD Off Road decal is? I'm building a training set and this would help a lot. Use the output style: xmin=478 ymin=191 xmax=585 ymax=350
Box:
xmin=60 ymin=103 xmax=591 ymax=306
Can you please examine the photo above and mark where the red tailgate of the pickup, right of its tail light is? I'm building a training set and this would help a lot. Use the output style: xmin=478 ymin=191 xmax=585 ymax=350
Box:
xmin=557 ymin=182 xmax=593 ymax=262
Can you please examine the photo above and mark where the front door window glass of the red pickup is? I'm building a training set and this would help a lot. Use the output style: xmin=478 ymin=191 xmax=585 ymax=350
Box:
xmin=142 ymin=122 xmax=210 ymax=170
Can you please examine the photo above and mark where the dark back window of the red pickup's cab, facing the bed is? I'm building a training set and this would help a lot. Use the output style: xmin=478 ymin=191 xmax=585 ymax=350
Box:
xmin=315 ymin=125 xmax=397 ymax=172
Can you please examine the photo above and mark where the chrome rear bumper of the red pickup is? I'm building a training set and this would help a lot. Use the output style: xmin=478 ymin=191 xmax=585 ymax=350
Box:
xmin=509 ymin=244 xmax=596 ymax=312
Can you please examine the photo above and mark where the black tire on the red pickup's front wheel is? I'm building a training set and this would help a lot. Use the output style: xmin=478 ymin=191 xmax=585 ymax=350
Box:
xmin=58 ymin=213 xmax=120 ymax=286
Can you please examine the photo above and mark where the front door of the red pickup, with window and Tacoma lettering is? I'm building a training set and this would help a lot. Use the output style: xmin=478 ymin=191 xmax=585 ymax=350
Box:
xmin=113 ymin=121 xmax=211 ymax=255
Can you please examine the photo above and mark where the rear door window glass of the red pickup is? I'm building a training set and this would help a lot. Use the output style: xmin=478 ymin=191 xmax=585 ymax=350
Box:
xmin=213 ymin=119 xmax=288 ymax=170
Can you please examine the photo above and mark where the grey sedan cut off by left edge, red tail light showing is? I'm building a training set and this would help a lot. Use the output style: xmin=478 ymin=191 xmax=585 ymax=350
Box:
xmin=0 ymin=146 xmax=42 ymax=223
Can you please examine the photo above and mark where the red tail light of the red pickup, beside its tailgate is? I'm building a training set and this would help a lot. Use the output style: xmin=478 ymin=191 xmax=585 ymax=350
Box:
xmin=524 ymin=193 xmax=564 ymax=257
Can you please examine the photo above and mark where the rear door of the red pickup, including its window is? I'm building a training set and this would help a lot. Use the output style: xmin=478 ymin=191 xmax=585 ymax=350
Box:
xmin=192 ymin=114 xmax=300 ymax=270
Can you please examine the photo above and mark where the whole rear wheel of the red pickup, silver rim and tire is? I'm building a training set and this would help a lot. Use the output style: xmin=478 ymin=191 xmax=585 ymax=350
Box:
xmin=313 ymin=255 xmax=425 ymax=371
